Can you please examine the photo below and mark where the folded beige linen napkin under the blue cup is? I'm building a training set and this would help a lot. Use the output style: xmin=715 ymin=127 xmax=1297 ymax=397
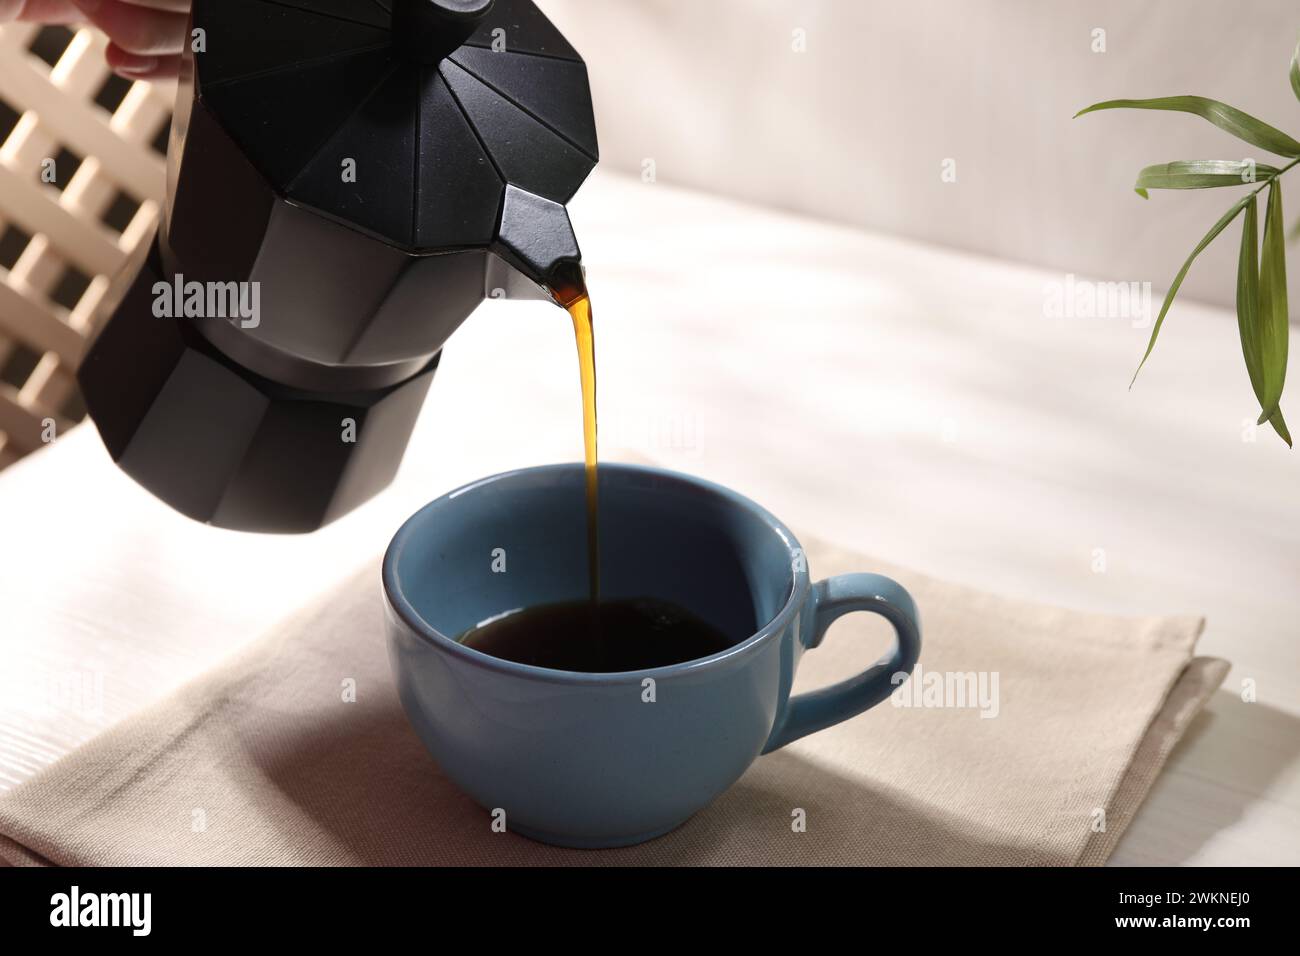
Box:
xmin=0 ymin=540 xmax=1227 ymax=865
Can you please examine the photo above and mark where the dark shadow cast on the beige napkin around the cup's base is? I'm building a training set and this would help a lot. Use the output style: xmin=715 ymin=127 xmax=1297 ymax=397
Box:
xmin=244 ymin=688 xmax=1070 ymax=865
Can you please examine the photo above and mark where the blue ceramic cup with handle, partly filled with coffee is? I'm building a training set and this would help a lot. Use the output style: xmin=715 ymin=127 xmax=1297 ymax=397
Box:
xmin=384 ymin=464 xmax=920 ymax=847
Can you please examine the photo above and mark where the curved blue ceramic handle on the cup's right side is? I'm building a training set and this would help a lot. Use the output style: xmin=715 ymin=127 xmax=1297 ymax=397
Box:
xmin=763 ymin=574 xmax=920 ymax=753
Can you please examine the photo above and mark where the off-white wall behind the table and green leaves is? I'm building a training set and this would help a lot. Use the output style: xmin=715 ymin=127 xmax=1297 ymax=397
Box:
xmin=540 ymin=0 xmax=1300 ymax=304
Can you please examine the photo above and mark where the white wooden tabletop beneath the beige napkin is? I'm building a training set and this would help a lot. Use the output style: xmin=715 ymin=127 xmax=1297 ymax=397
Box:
xmin=0 ymin=167 xmax=1300 ymax=865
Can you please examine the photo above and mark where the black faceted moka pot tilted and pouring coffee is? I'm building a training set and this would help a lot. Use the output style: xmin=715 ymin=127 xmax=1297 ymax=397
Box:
xmin=78 ymin=0 xmax=597 ymax=532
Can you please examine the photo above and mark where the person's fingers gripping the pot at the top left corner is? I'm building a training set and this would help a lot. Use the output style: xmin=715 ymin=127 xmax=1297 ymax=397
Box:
xmin=0 ymin=0 xmax=190 ymax=79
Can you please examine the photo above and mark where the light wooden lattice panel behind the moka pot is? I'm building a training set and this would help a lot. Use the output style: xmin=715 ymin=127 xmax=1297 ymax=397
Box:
xmin=0 ymin=23 xmax=176 ymax=468
